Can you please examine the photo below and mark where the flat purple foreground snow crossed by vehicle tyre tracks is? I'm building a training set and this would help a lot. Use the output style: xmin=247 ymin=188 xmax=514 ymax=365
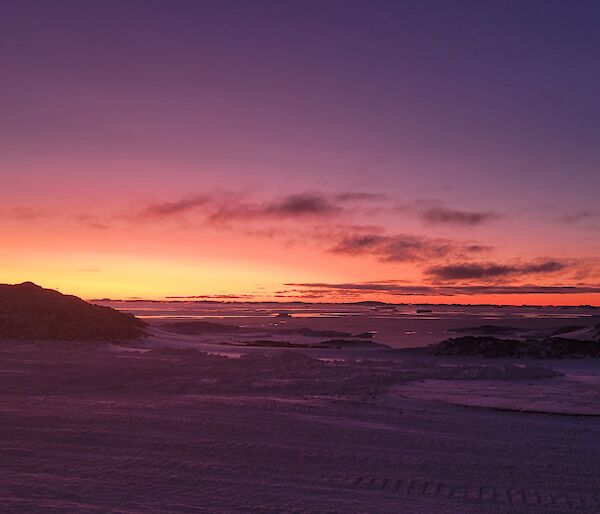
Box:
xmin=0 ymin=378 xmax=600 ymax=514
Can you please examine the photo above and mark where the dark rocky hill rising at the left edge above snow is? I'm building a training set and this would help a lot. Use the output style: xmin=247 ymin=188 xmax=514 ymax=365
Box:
xmin=0 ymin=282 xmax=146 ymax=341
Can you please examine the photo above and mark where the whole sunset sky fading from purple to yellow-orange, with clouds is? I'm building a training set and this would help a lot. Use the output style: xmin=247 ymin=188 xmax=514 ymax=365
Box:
xmin=0 ymin=0 xmax=600 ymax=305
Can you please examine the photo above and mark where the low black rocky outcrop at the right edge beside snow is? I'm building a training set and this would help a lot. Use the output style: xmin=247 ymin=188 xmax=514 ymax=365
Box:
xmin=430 ymin=336 xmax=600 ymax=359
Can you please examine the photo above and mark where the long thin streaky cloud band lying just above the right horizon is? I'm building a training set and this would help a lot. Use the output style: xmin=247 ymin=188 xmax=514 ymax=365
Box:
xmin=285 ymin=280 xmax=600 ymax=297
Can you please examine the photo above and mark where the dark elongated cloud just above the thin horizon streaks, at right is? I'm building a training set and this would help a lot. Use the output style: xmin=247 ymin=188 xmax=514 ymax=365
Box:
xmin=426 ymin=261 xmax=567 ymax=280
